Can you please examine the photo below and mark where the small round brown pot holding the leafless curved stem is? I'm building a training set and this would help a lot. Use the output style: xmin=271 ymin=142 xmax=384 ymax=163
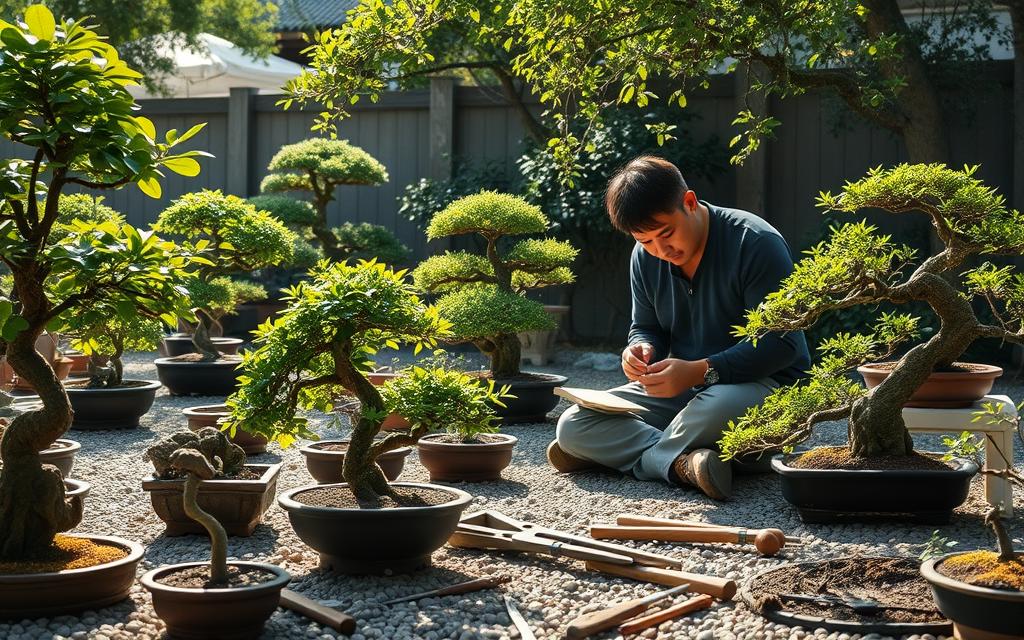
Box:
xmin=139 ymin=560 xmax=292 ymax=640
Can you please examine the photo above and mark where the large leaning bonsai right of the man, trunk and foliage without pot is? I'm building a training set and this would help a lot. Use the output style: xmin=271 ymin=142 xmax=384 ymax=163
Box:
xmin=721 ymin=165 xmax=1024 ymax=457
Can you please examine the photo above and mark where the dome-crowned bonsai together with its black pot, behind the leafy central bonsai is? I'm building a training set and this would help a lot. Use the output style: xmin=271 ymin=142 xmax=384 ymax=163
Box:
xmin=155 ymin=190 xmax=295 ymax=395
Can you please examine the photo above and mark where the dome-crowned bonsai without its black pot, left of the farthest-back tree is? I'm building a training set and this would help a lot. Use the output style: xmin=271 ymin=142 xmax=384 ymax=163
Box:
xmin=154 ymin=189 xmax=295 ymax=361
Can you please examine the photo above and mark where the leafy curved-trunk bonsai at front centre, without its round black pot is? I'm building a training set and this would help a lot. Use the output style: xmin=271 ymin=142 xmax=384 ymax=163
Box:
xmin=224 ymin=261 xmax=507 ymax=506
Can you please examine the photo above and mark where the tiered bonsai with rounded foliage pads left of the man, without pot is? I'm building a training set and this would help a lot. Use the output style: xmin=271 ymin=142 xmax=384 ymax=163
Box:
xmin=413 ymin=191 xmax=578 ymax=379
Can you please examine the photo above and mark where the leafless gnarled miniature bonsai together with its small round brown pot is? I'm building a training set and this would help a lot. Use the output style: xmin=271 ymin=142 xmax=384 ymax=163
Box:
xmin=140 ymin=429 xmax=291 ymax=640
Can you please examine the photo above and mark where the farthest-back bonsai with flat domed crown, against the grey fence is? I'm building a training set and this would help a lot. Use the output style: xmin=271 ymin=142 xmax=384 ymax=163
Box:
xmin=257 ymin=138 xmax=409 ymax=263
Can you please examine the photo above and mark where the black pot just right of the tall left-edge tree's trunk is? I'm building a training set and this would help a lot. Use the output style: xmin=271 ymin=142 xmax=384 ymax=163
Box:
xmin=65 ymin=380 xmax=161 ymax=431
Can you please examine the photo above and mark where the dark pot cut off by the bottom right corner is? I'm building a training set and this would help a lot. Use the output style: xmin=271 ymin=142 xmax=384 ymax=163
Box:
xmin=921 ymin=552 xmax=1024 ymax=640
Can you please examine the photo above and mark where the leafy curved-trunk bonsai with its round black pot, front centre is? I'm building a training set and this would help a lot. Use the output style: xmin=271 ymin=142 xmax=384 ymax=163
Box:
xmin=227 ymin=262 xmax=507 ymax=573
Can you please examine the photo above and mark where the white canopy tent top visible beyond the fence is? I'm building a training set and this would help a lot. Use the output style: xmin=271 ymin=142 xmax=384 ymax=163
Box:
xmin=128 ymin=34 xmax=302 ymax=99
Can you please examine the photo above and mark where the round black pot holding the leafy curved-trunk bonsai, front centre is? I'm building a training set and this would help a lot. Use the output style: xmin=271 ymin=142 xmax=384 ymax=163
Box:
xmin=278 ymin=482 xmax=473 ymax=574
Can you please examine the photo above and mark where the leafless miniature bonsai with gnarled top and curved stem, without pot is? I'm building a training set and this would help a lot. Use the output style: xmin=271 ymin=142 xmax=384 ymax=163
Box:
xmin=145 ymin=427 xmax=246 ymax=585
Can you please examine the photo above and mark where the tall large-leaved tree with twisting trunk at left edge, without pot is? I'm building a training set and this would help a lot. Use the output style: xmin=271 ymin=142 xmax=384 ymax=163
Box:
xmin=0 ymin=5 xmax=202 ymax=561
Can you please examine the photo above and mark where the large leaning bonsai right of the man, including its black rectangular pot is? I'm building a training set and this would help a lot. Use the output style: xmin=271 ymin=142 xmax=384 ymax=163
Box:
xmin=720 ymin=165 xmax=1024 ymax=521
